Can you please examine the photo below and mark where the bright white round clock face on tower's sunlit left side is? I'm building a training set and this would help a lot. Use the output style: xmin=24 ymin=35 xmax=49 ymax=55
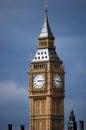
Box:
xmin=33 ymin=74 xmax=45 ymax=88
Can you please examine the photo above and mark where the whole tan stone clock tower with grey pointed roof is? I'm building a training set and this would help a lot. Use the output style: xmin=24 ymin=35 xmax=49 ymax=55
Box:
xmin=28 ymin=3 xmax=64 ymax=130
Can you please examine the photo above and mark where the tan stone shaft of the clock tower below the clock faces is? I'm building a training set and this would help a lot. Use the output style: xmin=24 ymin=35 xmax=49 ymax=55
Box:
xmin=30 ymin=95 xmax=64 ymax=130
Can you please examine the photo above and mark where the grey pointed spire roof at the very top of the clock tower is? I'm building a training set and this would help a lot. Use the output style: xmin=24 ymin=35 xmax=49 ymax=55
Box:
xmin=38 ymin=8 xmax=54 ymax=39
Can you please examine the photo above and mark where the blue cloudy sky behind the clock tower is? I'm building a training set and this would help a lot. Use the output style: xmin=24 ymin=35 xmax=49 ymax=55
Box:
xmin=0 ymin=0 xmax=86 ymax=130
